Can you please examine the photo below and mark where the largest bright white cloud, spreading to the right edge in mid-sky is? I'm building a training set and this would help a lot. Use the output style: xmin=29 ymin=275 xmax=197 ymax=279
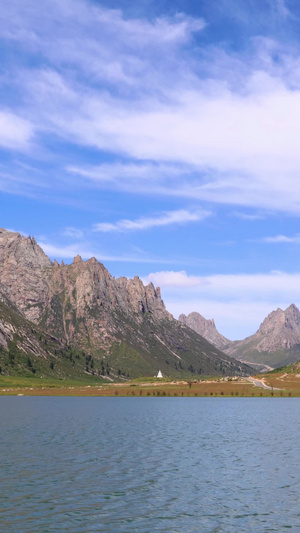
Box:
xmin=61 ymin=79 xmax=300 ymax=212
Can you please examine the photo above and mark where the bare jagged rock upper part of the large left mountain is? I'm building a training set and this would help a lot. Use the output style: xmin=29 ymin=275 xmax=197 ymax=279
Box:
xmin=0 ymin=230 xmax=172 ymax=345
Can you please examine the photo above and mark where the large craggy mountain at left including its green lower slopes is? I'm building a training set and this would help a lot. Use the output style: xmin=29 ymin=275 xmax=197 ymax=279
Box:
xmin=0 ymin=229 xmax=251 ymax=379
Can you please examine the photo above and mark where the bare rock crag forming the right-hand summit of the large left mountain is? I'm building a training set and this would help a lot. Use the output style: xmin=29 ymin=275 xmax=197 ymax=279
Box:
xmin=40 ymin=256 xmax=172 ymax=350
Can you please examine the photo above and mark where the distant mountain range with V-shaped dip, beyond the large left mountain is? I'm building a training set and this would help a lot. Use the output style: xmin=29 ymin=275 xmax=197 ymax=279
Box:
xmin=183 ymin=304 xmax=300 ymax=369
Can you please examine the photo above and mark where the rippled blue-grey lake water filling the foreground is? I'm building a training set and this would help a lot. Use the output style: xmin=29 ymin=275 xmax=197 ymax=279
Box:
xmin=0 ymin=397 xmax=300 ymax=533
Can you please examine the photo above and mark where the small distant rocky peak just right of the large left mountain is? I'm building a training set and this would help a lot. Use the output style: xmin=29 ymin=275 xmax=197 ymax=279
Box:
xmin=179 ymin=312 xmax=230 ymax=350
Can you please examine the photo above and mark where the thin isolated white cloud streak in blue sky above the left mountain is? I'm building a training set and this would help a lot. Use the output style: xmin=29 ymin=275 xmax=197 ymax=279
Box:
xmin=94 ymin=209 xmax=211 ymax=232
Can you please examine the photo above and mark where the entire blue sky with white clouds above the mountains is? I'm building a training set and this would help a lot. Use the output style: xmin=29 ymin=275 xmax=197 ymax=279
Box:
xmin=0 ymin=0 xmax=300 ymax=339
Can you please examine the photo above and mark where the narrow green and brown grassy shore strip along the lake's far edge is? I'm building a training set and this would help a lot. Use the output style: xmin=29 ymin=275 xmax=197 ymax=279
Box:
xmin=0 ymin=373 xmax=300 ymax=397
